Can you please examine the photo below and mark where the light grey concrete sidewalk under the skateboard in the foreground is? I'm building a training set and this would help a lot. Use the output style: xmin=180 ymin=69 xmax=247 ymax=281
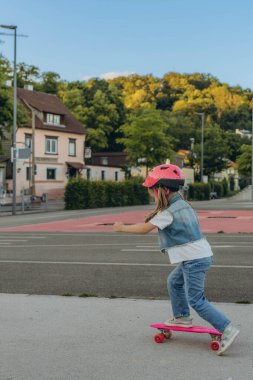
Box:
xmin=0 ymin=294 xmax=253 ymax=380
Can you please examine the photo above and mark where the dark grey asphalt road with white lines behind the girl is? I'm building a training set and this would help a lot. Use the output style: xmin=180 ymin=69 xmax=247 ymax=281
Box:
xmin=0 ymin=232 xmax=253 ymax=302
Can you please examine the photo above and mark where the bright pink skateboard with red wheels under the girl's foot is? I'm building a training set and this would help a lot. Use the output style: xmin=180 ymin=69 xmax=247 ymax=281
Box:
xmin=150 ymin=323 xmax=222 ymax=351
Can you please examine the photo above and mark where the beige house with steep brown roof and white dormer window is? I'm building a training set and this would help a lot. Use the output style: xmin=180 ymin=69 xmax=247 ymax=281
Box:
xmin=6 ymin=88 xmax=87 ymax=199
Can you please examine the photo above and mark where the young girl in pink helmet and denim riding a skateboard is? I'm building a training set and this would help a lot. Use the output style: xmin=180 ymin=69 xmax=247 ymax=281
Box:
xmin=113 ymin=164 xmax=239 ymax=355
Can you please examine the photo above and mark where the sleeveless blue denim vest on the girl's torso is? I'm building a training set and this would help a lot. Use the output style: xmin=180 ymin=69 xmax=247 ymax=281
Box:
xmin=158 ymin=194 xmax=204 ymax=251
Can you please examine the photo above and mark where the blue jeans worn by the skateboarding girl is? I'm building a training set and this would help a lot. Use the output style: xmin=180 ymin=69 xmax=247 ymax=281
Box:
xmin=167 ymin=257 xmax=230 ymax=332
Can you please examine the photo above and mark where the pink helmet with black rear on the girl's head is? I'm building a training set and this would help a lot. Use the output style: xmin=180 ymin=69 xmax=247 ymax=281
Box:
xmin=143 ymin=164 xmax=184 ymax=190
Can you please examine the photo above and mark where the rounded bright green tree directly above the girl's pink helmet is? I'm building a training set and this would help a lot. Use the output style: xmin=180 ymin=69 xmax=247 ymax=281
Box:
xmin=118 ymin=108 xmax=172 ymax=168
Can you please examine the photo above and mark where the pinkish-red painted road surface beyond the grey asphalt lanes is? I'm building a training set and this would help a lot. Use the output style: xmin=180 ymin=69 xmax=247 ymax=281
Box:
xmin=0 ymin=210 xmax=253 ymax=233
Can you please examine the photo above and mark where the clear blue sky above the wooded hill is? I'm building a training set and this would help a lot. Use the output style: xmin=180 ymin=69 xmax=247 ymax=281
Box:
xmin=0 ymin=0 xmax=253 ymax=89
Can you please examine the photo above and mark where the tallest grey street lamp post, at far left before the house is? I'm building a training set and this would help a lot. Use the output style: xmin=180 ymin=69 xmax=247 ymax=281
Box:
xmin=0 ymin=25 xmax=17 ymax=215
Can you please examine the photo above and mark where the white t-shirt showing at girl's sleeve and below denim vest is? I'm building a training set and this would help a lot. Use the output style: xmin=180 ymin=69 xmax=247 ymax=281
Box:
xmin=149 ymin=210 xmax=213 ymax=264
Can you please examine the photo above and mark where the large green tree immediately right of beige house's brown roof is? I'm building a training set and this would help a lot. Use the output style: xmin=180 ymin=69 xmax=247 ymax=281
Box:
xmin=59 ymin=78 xmax=126 ymax=152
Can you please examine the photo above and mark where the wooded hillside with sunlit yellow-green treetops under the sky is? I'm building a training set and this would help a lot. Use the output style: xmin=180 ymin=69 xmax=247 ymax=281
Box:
xmin=0 ymin=56 xmax=253 ymax=183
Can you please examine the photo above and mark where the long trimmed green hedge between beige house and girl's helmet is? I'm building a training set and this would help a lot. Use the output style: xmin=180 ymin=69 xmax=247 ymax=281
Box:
xmin=64 ymin=177 xmax=149 ymax=210
